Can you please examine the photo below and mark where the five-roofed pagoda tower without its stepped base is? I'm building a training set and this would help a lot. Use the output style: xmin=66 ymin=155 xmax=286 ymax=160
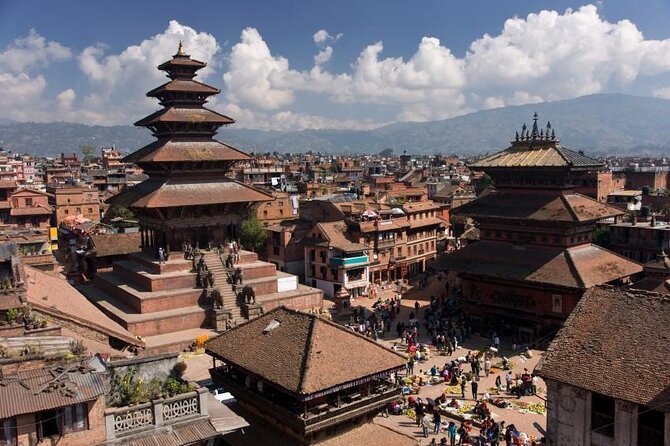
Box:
xmin=109 ymin=43 xmax=272 ymax=253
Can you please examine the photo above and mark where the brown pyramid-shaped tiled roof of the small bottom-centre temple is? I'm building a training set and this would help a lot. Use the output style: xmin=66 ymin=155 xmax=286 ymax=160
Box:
xmin=205 ymin=307 xmax=406 ymax=395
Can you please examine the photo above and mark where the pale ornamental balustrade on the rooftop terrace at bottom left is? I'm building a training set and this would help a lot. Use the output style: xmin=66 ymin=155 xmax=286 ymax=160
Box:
xmin=105 ymin=388 xmax=207 ymax=440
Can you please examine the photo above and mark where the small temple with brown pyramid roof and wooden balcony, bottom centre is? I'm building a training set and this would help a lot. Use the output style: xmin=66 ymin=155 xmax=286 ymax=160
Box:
xmin=205 ymin=307 xmax=407 ymax=444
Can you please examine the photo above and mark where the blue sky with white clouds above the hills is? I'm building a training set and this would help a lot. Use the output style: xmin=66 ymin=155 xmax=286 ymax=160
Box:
xmin=0 ymin=0 xmax=670 ymax=129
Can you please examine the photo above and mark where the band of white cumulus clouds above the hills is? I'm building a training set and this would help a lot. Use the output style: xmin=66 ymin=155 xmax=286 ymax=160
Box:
xmin=6 ymin=5 xmax=670 ymax=129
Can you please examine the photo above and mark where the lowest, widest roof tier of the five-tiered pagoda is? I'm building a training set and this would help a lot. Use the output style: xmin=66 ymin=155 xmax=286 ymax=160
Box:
xmin=107 ymin=177 xmax=272 ymax=208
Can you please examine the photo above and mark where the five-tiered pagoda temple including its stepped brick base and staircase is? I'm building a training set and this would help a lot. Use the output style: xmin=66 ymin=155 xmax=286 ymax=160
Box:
xmin=79 ymin=44 xmax=323 ymax=353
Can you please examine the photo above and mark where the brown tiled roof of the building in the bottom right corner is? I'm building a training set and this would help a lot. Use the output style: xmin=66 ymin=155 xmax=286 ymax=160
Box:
xmin=535 ymin=286 xmax=670 ymax=411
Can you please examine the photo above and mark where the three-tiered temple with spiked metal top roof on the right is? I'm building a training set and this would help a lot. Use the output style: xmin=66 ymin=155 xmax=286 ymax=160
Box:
xmin=446 ymin=114 xmax=642 ymax=341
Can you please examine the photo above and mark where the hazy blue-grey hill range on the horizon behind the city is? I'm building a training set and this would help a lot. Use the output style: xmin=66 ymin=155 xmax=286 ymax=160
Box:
xmin=0 ymin=94 xmax=670 ymax=155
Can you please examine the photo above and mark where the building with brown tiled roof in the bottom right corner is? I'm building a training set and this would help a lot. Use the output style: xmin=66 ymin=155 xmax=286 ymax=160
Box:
xmin=535 ymin=286 xmax=670 ymax=446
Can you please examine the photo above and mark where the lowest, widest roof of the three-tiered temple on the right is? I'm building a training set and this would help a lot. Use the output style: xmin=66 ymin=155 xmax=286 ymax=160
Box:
xmin=444 ymin=240 xmax=642 ymax=289
